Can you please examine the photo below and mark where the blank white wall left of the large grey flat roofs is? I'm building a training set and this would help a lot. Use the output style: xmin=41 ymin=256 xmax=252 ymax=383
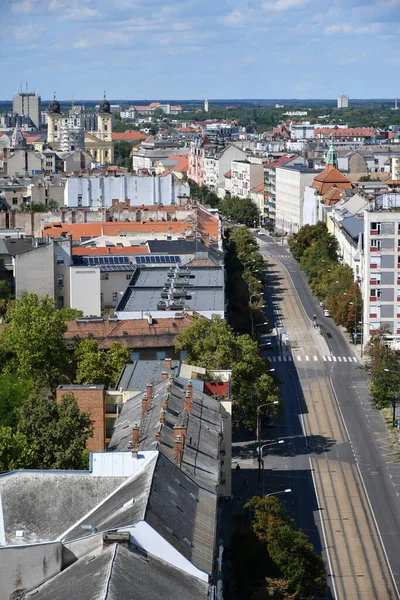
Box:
xmin=70 ymin=267 xmax=101 ymax=317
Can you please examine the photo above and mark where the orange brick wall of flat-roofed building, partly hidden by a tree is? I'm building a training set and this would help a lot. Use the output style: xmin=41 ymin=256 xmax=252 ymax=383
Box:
xmin=56 ymin=385 xmax=106 ymax=452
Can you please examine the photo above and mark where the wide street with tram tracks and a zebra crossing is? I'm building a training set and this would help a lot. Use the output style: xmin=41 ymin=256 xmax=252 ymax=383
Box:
xmin=243 ymin=235 xmax=400 ymax=600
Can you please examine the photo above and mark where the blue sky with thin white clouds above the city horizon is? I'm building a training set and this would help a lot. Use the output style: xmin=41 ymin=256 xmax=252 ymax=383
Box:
xmin=0 ymin=0 xmax=400 ymax=100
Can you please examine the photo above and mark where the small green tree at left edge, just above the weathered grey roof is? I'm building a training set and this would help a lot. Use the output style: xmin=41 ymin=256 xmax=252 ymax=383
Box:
xmin=0 ymin=427 xmax=37 ymax=472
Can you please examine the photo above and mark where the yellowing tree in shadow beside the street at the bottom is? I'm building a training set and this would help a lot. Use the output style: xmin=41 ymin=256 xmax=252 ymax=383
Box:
xmin=246 ymin=496 xmax=327 ymax=600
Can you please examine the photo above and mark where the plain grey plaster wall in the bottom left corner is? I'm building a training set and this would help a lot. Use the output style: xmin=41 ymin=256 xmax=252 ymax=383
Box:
xmin=0 ymin=540 xmax=62 ymax=600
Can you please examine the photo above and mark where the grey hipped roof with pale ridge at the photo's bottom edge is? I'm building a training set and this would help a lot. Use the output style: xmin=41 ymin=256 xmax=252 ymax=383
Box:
xmin=27 ymin=545 xmax=209 ymax=600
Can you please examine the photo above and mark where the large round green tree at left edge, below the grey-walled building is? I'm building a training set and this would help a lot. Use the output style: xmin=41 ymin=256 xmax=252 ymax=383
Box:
xmin=0 ymin=294 xmax=70 ymax=389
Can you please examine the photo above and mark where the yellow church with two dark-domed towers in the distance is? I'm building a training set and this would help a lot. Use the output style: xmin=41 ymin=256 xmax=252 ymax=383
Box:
xmin=47 ymin=99 xmax=114 ymax=165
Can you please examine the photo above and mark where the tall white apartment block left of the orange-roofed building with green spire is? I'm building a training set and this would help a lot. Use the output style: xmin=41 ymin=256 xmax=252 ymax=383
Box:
xmin=275 ymin=165 xmax=318 ymax=234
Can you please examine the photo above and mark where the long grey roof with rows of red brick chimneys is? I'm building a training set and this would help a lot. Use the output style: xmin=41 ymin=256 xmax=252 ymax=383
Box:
xmin=108 ymin=379 xmax=222 ymax=492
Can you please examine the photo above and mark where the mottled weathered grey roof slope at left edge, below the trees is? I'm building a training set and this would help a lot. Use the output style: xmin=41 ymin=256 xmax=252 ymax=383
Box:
xmin=0 ymin=471 xmax=126 ymax=544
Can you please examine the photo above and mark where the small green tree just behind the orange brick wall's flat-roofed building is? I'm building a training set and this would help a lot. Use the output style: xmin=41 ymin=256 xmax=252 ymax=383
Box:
xmin=75 ymin=339 xmax=131 ymax=387
